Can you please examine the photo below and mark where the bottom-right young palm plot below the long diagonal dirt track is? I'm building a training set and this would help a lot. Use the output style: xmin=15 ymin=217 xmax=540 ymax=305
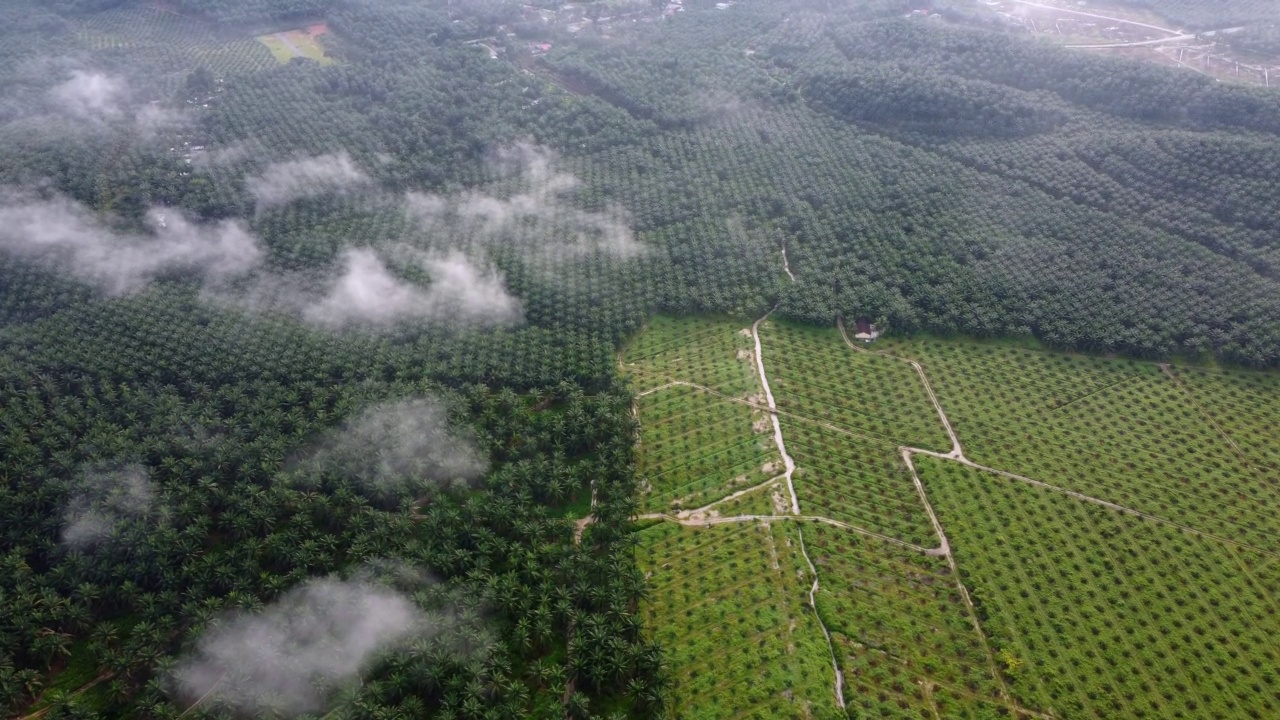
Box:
xmin=918 ymin=457 xmax=1280 ymax=717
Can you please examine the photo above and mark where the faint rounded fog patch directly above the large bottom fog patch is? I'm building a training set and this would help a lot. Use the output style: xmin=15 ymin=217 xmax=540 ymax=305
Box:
xmin=298 ymin=397 xmax=489 ymax=492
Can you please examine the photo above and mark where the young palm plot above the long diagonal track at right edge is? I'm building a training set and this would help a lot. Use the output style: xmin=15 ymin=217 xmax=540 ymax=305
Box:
xmin=884 ymin=341 xmax=1280 ymax=550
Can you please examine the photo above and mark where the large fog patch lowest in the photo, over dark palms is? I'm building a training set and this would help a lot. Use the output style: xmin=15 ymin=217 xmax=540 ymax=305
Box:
xmin=174 ymin=578 xmax=432 ymax=715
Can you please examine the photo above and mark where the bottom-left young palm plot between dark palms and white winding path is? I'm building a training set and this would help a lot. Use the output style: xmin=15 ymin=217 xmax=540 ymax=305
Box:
xmin=636 ymin=523 xmax=838 ymax=719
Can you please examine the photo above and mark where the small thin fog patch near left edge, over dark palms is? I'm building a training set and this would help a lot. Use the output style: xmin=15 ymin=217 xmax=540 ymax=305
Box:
xmin=61 ymin=465 xmax=155 ymax=548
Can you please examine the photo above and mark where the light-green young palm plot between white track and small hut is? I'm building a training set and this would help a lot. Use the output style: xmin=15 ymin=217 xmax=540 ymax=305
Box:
xmin=760 ymin=320 xmax=951 ymax=452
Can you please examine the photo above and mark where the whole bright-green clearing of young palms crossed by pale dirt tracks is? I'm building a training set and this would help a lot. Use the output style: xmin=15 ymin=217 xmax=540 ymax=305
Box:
xmin=620 ymin=318 xmax=1280 ymax=719
